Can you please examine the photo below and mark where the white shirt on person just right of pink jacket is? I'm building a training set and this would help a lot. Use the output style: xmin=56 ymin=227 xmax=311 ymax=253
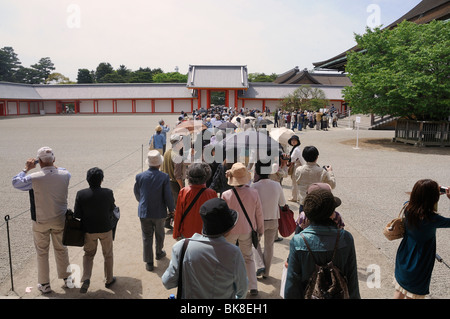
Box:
xmin=251 ymin=179 xmax=286 ymax=220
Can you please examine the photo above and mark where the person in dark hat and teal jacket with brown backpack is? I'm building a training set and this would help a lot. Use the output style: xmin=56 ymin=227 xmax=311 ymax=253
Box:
xmin=284 ymin=189 xmax=361 ymax=299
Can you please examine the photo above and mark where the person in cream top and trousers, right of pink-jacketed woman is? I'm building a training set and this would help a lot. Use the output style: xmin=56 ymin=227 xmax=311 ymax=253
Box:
xmin=250 ymin=161 xmax=286 ymax=278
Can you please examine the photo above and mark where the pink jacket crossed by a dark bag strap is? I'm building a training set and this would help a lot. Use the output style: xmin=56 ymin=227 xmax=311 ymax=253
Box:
xmin=222 ymin=185 xmax=264 ymax=235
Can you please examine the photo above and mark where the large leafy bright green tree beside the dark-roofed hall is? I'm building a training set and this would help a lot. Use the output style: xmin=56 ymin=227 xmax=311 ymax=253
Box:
xmin=343 ymin=21 xmax=450 ymax=120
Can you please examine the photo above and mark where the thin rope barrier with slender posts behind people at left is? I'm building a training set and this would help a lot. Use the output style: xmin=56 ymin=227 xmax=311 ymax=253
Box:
xmin=0 ymin=144 xmax=144 ymax=291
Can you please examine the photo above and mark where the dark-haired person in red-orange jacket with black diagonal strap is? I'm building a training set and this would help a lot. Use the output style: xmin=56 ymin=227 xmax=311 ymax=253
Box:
xmin=173 ymin=162 xmax=217 ymax=239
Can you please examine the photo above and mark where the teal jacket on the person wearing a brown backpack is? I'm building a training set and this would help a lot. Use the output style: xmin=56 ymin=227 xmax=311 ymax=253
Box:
xmin=284 ymin=225 xmax=361 ymax=299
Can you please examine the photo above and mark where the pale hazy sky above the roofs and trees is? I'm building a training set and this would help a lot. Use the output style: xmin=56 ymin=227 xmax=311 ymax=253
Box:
xmin=0 ymin=0 xmax=420 ymax=81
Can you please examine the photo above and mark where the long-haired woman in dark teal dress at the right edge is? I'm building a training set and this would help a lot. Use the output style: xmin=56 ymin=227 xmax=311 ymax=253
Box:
xmin=394 ymin=179 xmax=450 ymax=299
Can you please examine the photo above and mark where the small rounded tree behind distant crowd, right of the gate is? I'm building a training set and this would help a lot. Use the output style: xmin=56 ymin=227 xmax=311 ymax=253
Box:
xmin=280 ymin=84 xmax=329 ymax=111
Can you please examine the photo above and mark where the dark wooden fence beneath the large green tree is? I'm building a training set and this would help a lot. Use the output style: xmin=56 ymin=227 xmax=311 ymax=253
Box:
xmin=394 ymin=120 xmax=450 ymax=147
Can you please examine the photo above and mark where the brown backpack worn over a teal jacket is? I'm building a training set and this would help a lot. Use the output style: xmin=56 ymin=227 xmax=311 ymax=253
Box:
xmin=300 ymin=231 xmax=349 ymax=299
